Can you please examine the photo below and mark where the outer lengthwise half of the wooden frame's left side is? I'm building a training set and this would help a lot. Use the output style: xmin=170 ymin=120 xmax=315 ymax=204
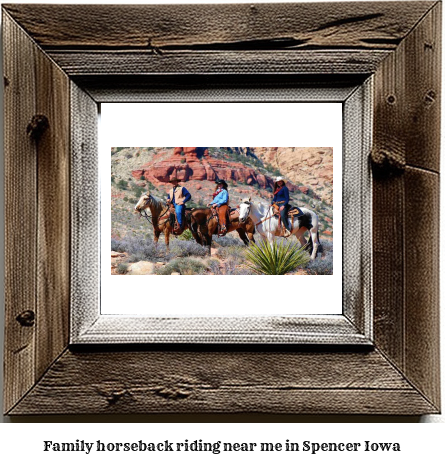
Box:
xmin=3 ymin=15 xmax=37 ymax=411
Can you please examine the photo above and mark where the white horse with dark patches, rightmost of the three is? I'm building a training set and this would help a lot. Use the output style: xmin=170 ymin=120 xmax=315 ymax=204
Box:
xmin=240 ymin=197 xmax=321 ymax=260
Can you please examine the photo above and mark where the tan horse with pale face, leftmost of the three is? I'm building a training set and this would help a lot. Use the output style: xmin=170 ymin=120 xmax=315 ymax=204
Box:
xmin=134 ymin=191 xmax=200 ymax=251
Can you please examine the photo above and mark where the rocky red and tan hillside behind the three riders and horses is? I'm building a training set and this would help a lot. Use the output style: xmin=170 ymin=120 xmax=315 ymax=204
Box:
xmin=111 ymin=147 xmax=333 ymax=271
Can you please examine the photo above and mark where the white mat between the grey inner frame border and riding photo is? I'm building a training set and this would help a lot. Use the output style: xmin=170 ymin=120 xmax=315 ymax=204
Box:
xmin=99 ymin=103 xmax=342 ymax=316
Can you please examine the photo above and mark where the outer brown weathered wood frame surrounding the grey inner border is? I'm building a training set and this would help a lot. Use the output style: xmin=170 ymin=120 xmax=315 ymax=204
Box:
xmin=3 ymin=1 xmax=441 ymax=415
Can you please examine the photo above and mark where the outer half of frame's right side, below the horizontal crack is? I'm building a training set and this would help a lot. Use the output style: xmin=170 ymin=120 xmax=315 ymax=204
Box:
xmin=404 ymin=167 xmax=440 ymax=407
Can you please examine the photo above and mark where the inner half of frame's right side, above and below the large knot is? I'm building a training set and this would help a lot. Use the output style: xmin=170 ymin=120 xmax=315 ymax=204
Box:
xmin=372 ymin=43 xmax=406 ymax=369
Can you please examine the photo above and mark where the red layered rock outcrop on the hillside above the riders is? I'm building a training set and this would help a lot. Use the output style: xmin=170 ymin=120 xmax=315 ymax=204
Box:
xmin=131 ymin=147 xmax=297 ymax=191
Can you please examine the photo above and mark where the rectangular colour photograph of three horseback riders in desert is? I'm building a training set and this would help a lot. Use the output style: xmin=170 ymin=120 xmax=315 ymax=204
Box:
xmin=111 ymin=147 xmax=334 ymax=275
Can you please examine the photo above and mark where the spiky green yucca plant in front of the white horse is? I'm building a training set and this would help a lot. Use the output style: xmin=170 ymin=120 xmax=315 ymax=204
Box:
xmin=246 ymin=237 xmax=310 ymax=275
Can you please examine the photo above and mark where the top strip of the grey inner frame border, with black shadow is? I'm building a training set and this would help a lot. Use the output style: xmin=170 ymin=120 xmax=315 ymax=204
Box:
xmin=73 ymin=74 xmax=363 ymax=103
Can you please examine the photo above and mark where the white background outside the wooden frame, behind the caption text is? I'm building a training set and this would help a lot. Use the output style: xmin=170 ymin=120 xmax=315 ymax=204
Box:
xmin=0 ymin=0 xmax=445 ymax=456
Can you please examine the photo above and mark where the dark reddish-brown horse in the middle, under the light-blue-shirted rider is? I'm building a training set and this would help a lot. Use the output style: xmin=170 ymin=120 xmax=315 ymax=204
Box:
xmin=190 ymin=208 xmax=255 ymax=249
